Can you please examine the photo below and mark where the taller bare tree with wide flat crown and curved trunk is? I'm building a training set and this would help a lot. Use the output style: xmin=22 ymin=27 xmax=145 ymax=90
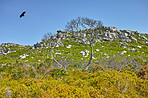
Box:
xmin=65 ymin=17 xmax=103 ymax=71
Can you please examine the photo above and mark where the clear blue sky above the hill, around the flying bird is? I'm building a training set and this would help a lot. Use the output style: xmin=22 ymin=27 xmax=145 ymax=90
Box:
xmin=0 ymin=0 xmax=148 ymax=45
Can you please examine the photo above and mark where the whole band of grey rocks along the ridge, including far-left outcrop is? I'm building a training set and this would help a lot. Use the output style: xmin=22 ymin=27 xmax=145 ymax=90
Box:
xmin=0 ymin=26 xmax=148 ymax=52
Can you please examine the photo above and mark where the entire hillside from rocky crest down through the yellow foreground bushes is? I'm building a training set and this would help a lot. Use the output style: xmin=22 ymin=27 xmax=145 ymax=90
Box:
xmin=0 ymin=26 xmax=148 ymax=98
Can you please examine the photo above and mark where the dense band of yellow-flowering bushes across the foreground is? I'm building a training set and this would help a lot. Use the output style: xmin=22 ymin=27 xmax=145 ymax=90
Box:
xmin=0 ymin=69 xmax=148 ymax=98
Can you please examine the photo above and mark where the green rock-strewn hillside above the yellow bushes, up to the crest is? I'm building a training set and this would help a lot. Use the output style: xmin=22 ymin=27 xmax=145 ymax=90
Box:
xmin=0 ymin=26 xmax=148 ymax=66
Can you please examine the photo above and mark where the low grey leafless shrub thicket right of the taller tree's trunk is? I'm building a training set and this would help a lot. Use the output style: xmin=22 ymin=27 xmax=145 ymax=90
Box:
xmin=90 ymin=54 xmax=142 ymax=72
